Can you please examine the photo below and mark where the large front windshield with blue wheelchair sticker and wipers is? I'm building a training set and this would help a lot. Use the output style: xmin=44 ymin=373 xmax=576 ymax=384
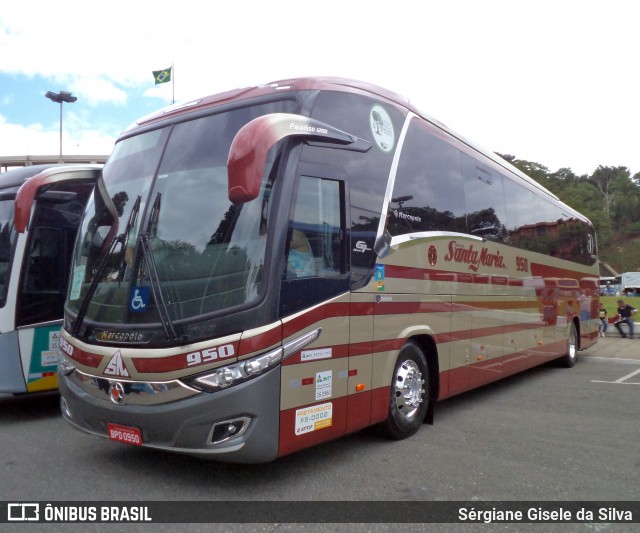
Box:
xmin=67 ymin=101 xmax=293 ymax=329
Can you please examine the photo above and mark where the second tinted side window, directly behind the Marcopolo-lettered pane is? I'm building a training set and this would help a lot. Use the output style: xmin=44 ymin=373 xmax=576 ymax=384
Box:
xmin=462 ymin=154 xmax=508 ymax=242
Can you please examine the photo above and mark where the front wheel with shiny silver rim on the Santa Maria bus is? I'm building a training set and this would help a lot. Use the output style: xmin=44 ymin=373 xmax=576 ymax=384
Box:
xmin=376 ymin=341 xmax=429 ymax=440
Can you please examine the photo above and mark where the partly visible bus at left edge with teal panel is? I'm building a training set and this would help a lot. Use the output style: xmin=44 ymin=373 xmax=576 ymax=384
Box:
xmin=0 ymin=165 xmax=101 ymax=394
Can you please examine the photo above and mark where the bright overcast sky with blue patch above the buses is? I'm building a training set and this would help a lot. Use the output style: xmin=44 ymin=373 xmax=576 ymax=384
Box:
xmin=0 ymin=0 xmax=640 ymax=174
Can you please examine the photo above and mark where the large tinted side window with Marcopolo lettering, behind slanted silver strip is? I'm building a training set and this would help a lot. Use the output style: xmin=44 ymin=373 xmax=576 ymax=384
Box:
xmin=387 ymin=119 xmax=466 ymax=236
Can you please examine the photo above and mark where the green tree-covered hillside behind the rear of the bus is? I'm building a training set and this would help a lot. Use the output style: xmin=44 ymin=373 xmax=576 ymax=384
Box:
xmin=498 ymin=154 xmax=640 ymax=273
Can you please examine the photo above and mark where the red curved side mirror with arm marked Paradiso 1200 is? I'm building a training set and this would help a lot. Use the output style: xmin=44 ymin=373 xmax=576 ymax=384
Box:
xmin=227 ymin=113 xmax=371 ymax=205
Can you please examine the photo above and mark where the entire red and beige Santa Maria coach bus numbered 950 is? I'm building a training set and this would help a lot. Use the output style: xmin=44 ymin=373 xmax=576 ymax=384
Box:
xmin=59 ymin=78 xmax=598 ymax=462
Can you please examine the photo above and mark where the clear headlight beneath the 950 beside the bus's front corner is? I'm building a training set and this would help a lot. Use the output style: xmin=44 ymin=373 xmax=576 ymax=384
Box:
xmin=182 ymin=348 xmax=283 ymax=392
